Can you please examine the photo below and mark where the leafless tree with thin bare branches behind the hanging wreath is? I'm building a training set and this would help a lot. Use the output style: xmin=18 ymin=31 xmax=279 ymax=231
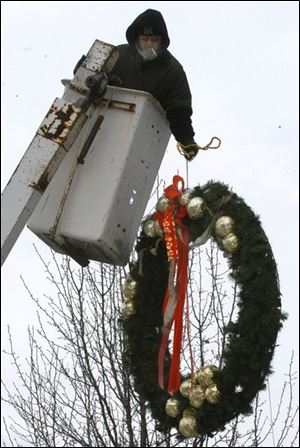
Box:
xmin=3 ymin=244 xmax=298 ymax=447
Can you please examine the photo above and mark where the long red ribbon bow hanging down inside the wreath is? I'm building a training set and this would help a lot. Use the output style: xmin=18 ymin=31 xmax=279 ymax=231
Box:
xmin=155 ymin=176 xmax=189 ymax=395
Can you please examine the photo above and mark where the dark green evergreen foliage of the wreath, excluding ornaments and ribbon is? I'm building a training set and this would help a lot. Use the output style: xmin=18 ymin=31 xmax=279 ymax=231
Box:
xmin=123 ymin=181 xmax=285 ymax=434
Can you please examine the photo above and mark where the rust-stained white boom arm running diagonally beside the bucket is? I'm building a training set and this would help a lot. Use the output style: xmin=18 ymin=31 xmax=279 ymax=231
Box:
xmin=1 ymin=40 xmax=118 ymax=265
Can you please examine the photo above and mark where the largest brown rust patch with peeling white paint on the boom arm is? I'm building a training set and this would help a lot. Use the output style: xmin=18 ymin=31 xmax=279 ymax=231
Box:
xmin=39 ymin=103 xmax=81 ymax=144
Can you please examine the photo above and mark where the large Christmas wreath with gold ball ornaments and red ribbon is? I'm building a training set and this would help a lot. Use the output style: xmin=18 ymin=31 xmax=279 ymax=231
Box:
xmin=123 ymin=176 xmax=285 ymax=437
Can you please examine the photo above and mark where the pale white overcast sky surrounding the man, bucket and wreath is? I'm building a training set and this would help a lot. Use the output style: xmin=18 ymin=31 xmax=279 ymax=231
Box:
xmin=1 ymin=1 xmax=299 ymax=444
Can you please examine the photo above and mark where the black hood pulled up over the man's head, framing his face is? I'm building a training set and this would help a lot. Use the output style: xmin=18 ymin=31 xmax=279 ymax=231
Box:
xmin=126 ymin=9 xmax=170 ymax=48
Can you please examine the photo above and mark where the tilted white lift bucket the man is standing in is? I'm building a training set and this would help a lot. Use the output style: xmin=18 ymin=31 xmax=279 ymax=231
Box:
xmin=28 ymin=87 xmax=170 ymax=265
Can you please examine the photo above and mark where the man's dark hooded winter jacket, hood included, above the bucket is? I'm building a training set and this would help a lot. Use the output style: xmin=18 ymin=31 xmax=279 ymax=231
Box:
xmin=111 ymin=9 xmax=194 ymax=143
